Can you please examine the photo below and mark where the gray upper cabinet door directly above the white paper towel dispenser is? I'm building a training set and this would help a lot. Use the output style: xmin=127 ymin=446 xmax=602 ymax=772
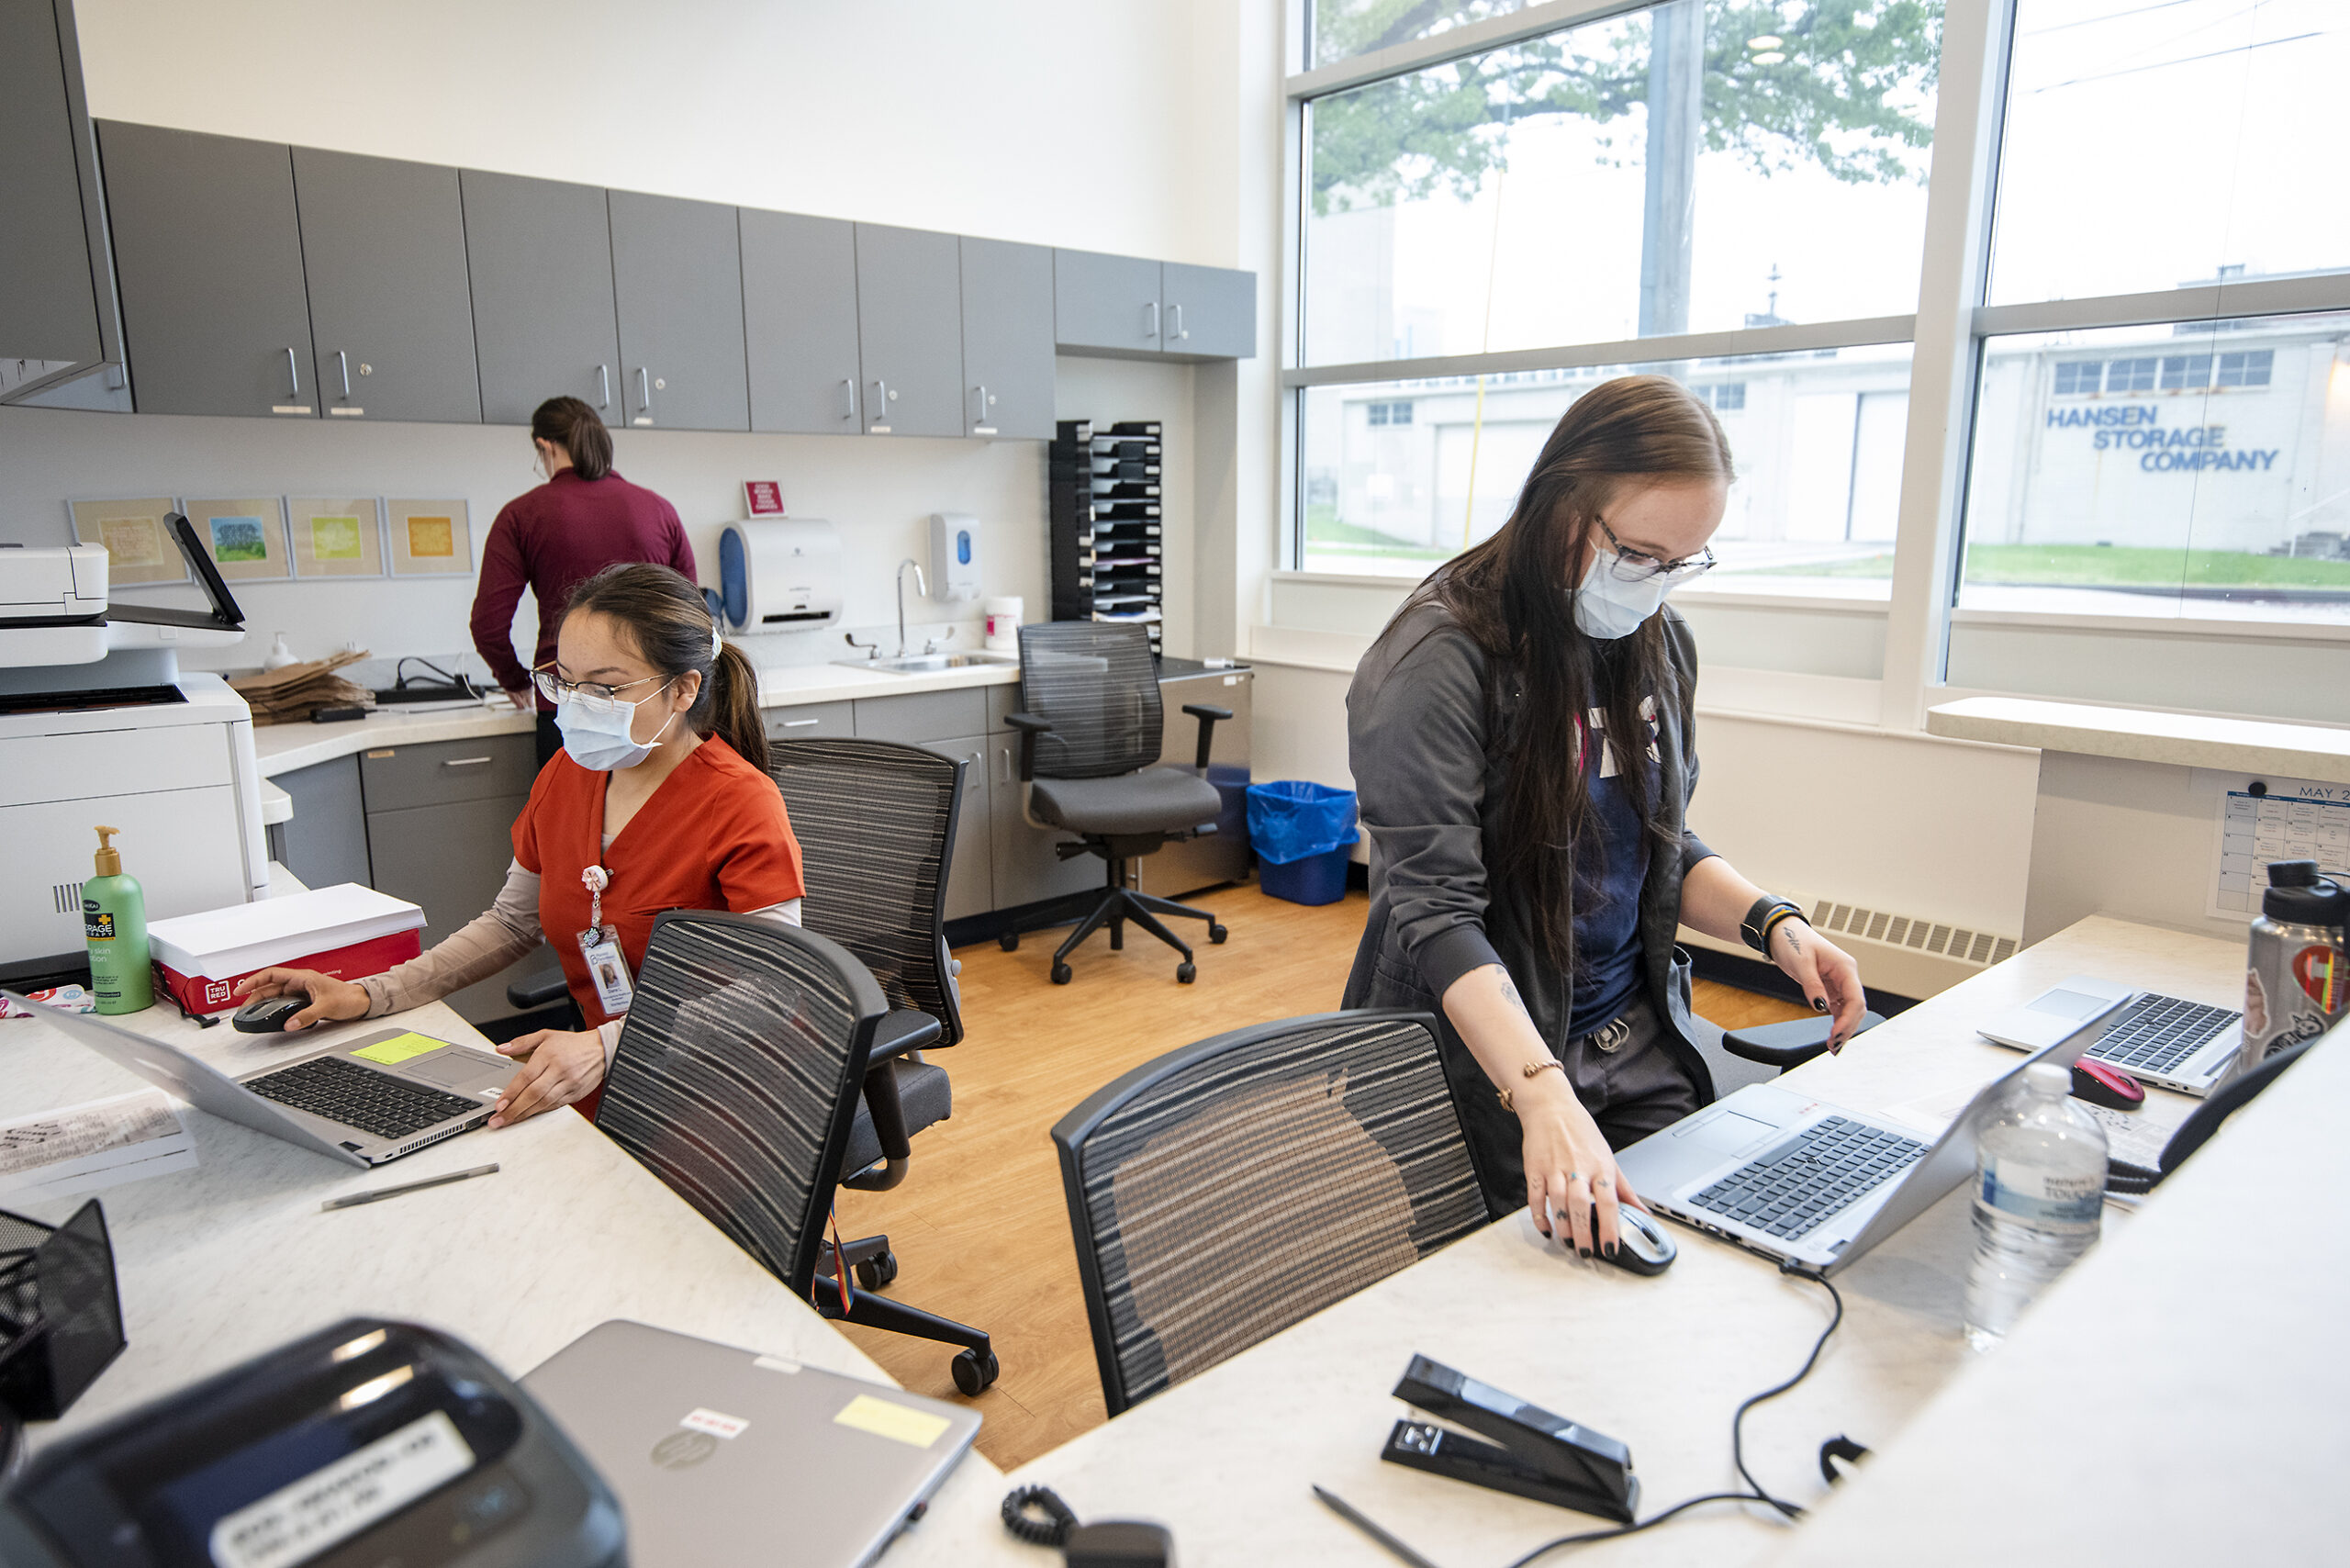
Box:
xmin=743 ymin=207 xmax=865 ymax=435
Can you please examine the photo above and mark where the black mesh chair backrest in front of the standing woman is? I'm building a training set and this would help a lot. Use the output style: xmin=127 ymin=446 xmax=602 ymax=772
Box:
xmin=1053 ymin=1011 xmax=1485 ymax=1416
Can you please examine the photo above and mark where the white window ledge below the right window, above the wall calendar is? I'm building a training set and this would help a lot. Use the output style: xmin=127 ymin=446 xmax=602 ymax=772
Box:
xmin=1925 ymin=696 xmax=2350 ymax=783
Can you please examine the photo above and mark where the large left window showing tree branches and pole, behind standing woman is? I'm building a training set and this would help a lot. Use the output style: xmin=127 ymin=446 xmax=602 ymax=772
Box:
xmin=1288 ymin=0 xmax=1942 ymax=597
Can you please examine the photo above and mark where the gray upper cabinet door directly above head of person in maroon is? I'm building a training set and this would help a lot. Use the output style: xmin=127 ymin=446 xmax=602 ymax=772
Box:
xmin=458 ymin=169 xmax=628 ymax=425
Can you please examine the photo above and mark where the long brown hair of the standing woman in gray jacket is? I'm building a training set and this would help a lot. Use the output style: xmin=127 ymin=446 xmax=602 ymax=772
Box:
xmin=1413 ymin=376 xmax=1734 ymax=971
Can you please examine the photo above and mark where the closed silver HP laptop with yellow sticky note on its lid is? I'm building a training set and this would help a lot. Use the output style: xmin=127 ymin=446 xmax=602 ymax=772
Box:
xmin=521 ymin=1321 xmax=980 ymax=1568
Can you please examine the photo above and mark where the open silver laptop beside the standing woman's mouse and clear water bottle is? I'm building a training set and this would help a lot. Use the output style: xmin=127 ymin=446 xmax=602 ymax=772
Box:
xmin=1617 ymin=1023 xmax=2097 ymax=1274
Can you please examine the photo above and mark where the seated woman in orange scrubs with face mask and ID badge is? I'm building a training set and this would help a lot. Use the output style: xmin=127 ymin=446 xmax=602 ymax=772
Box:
xmin=238 ymin=565 xmax=806 ymax=1126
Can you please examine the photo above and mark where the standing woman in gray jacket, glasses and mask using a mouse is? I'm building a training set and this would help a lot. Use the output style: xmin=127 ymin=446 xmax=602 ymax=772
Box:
xmin=1347 ymin=376 xmax=1863 ymax=1258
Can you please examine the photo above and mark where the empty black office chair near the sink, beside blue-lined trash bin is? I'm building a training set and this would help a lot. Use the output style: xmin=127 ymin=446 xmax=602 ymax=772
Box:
xmin=999 ymin=621 xmax=1231 ymax=985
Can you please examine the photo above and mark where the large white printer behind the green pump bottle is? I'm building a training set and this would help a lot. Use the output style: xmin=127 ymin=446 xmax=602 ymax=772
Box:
xmin=0 ymin=515 xmax=268 ymax=990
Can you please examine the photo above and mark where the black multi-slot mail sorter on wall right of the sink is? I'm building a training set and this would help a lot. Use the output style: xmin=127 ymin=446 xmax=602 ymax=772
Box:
xmin=1046 ymin=419 xmax=1166 ymax=655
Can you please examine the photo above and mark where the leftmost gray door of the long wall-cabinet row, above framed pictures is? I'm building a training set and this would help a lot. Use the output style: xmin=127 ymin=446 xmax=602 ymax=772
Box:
xmin=99 ymin=120 xmax=315 ymax=416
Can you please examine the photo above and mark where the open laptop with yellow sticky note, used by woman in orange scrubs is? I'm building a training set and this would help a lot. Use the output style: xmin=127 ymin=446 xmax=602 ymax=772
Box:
xmin=0 ymin=992 xmax=515 ymax=1166
